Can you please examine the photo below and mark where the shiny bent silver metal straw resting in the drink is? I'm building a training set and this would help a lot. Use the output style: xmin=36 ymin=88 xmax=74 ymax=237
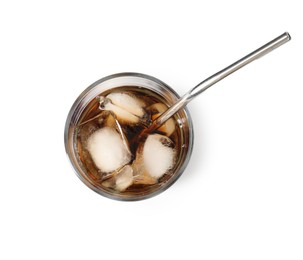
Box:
xmin=150 ymin=32 xmax=291 ymax=132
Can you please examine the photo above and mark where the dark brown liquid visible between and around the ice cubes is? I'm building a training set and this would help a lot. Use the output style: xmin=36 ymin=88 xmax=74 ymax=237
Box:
xmin=74 ymin=86 xmax=184 ymax=196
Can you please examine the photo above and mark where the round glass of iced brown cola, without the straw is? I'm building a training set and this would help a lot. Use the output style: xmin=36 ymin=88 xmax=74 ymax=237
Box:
xmin=65 ymin=74 xmax=192 ymax=200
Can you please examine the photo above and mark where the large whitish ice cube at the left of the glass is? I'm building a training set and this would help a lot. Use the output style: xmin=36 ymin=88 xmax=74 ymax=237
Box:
xmin=87 ymin=126 xmax=131 ymax=173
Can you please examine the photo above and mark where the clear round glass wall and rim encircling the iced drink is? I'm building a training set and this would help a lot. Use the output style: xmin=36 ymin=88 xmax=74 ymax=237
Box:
xmin=64 ymin=73 xmax=193 ymax=201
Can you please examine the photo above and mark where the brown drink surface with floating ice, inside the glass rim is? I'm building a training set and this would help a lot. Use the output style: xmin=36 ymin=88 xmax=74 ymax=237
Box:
xmin=74 ymin=86 xmax=185 ymax=197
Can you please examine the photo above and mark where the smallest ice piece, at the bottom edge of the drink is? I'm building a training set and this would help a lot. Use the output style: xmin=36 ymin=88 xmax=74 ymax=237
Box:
xmin=102 ymin=165 xmax=133 ymax=191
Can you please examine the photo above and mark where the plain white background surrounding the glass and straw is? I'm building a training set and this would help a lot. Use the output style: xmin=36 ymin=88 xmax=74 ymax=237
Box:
xmin=0 ymin=0 xmax=303 ymax=260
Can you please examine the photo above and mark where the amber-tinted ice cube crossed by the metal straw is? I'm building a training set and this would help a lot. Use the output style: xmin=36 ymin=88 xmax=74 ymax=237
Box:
xmin=148 ymin=103 xmax=176 ymax=136
